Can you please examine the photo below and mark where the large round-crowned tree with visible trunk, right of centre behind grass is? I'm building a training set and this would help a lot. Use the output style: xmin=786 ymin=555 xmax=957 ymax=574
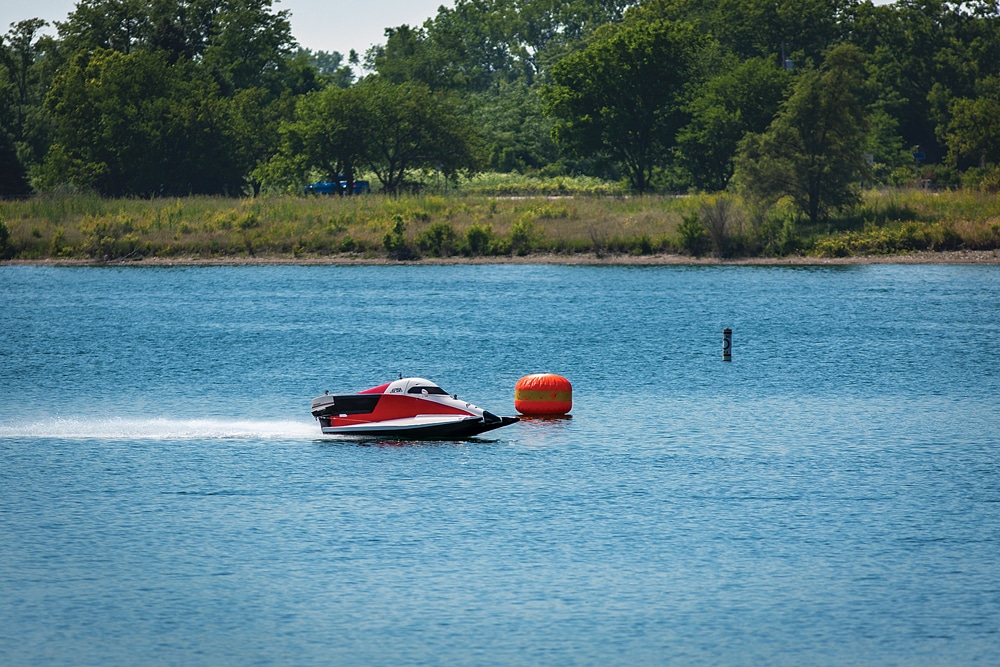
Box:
xmin=543 ymin=19 xmax=707 ymax=193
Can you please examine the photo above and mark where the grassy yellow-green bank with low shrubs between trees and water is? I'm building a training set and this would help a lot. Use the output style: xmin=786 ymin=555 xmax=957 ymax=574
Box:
xmin=0 ymin=191 xmax=1000 ymax=262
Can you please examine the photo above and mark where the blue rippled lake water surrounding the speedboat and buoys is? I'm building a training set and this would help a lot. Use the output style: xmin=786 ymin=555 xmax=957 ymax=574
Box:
xmin=0 ymin=265 xmax=1000 ymax=666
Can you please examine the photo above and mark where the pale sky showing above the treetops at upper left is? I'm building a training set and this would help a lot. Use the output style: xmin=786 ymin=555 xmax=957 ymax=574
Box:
xmin=0 ymin=0 xmax=454 ymax=56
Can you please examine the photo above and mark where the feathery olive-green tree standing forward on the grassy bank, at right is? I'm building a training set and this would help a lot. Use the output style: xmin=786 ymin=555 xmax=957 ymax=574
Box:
xmin=736 ymin=44 xmax=868 ymax=222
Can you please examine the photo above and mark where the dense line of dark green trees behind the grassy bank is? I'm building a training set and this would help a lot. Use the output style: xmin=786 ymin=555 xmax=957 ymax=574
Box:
xmin=0 ymin=0 xmax=1000 ymax=219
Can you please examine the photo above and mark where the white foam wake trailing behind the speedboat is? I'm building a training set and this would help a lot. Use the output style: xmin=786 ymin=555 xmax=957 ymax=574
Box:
xmin=0 ymin=417 xmax=320 ymax=440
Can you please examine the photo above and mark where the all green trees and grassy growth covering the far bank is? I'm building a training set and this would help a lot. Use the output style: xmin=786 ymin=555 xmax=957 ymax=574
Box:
xmin=0 ymin=0 xmax=1000 ymax=259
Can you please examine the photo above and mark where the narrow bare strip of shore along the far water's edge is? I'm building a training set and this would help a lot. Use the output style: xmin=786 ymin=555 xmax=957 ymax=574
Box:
xmin=0 ymin=250 xmax=1000 ymax=267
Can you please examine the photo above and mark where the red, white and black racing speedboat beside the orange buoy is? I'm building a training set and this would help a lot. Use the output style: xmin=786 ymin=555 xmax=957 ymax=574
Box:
xmin=312 ymin=378 xmax=520 ymax=438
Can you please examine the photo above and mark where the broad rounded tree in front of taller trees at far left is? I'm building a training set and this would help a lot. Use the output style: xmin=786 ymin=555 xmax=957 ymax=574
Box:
xmin=45 ymin=49 xmax=243 ymax=196
